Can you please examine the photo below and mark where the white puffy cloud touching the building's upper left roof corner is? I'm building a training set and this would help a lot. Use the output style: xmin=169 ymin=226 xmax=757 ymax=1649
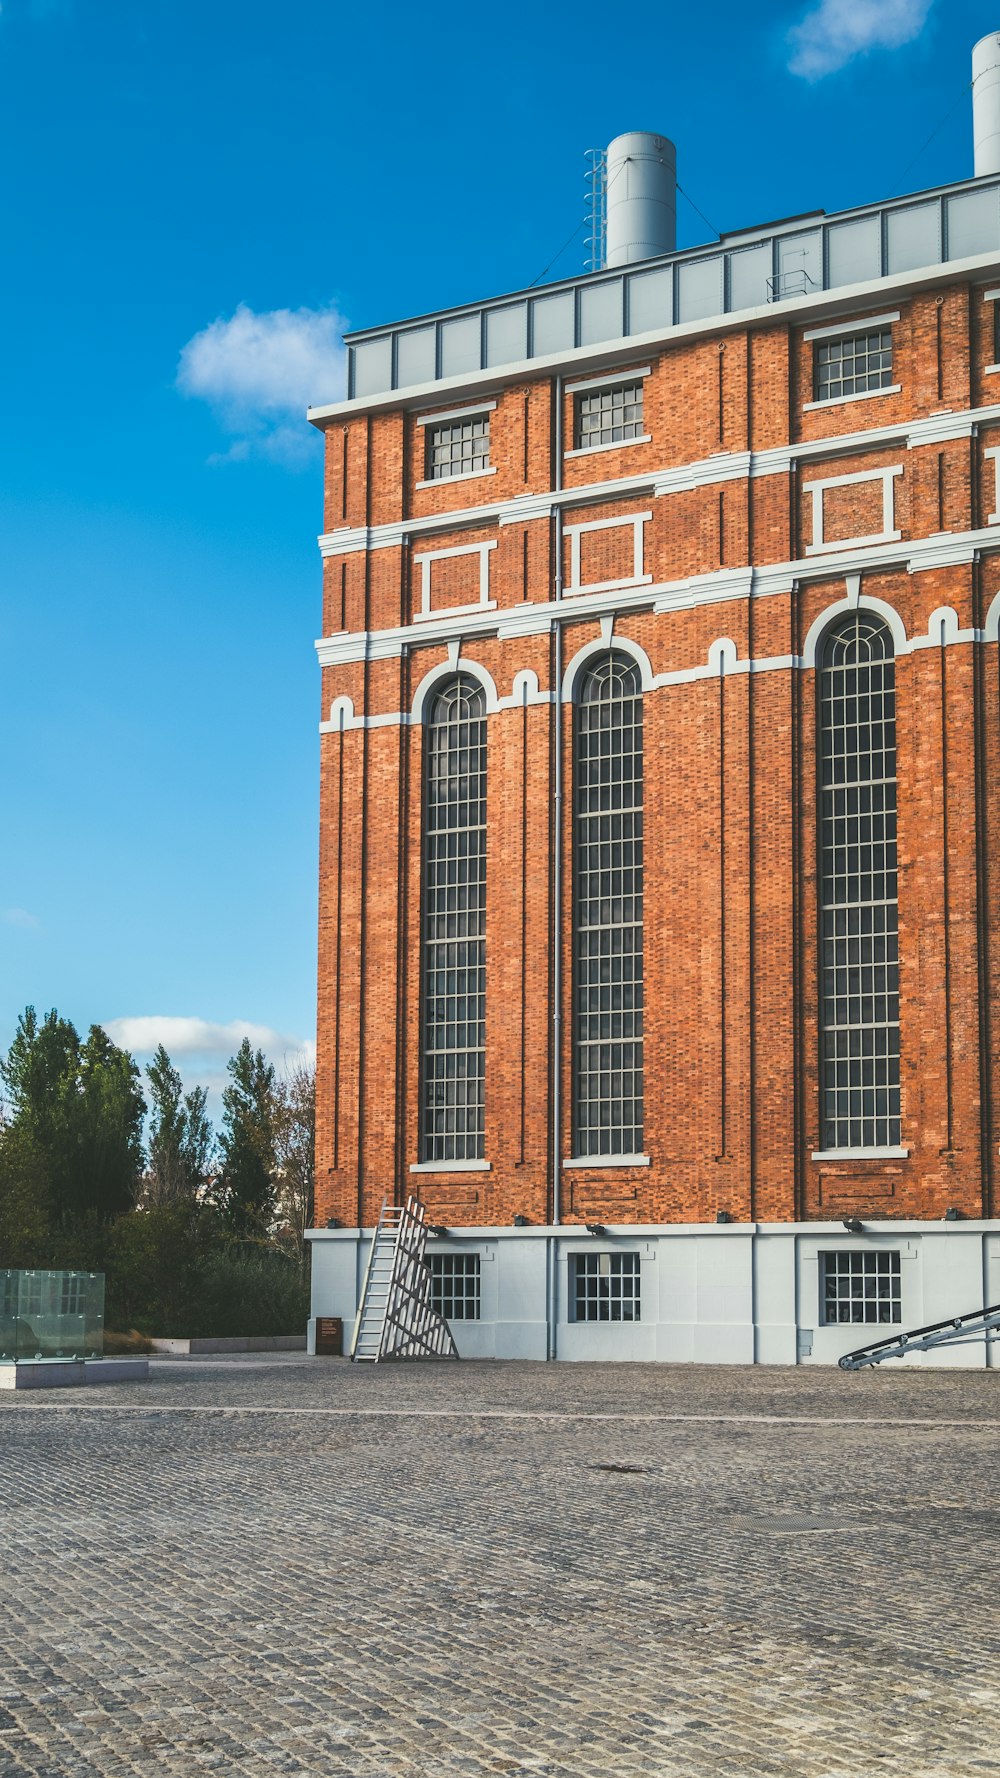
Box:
xmin=176 ymin=302 xmax=345 ymax=462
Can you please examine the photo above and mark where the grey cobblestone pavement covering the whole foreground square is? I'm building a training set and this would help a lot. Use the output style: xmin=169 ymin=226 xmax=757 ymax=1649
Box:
xmin=0 ymin=1355 xmax=1000 ymax=1778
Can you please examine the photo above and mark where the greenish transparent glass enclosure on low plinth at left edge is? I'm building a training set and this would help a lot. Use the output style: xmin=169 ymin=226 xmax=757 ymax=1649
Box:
xmin=0 ymin=1271 xmax=105 ymax=1364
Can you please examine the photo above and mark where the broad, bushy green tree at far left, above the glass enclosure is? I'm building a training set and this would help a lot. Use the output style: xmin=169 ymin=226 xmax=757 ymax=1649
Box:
xmin=0 ymin=1006 xmax=146 ymax=1227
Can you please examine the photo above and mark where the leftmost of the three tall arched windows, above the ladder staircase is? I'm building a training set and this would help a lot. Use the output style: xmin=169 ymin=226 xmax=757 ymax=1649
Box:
xmin=420 ymin=674 xmax=486 ymax=1166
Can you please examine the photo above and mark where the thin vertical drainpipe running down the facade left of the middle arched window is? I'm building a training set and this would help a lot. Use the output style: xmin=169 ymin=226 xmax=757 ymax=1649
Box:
xmin=548 ymin=375 xmax=562 ymax=1358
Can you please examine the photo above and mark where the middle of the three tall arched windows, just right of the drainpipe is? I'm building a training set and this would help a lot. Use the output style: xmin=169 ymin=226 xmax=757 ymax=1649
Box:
xmin=573 ymin=653 xmax=642 ymax=1156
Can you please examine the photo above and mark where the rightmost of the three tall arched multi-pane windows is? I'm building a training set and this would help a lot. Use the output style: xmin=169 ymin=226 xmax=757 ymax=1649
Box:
xmin=819 ymin=610 xmax=900 ymax=1149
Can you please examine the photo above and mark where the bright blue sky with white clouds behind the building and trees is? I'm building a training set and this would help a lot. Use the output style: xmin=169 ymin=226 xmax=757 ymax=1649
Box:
xmin=0 ymin=0 xmax=1000 ymax=1102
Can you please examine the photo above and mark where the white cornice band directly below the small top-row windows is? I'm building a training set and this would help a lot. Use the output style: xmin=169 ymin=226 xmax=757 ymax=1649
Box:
xmin=319 ymin=402 xmax=1000 ymax=557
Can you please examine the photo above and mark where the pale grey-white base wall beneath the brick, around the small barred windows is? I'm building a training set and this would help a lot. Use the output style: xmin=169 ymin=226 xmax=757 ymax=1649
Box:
xmin=308 ymin=1221 xmax=1000 ymax=1369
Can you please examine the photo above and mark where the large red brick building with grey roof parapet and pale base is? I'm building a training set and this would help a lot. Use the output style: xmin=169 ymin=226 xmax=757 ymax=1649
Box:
xmin=310 ymin=55 xmax=1000 ymax=1362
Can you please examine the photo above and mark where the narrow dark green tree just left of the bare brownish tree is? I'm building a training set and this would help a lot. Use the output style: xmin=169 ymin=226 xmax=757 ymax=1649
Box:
xmin=215 ymin=1037 xmax=278 ymax=1241
